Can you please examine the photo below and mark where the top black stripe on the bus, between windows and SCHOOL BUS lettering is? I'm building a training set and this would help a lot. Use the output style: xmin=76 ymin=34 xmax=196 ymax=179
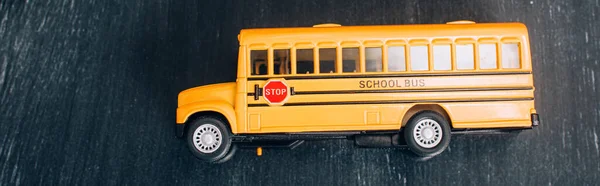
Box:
xmin=248 ymin=71 xmax=531 ymax=81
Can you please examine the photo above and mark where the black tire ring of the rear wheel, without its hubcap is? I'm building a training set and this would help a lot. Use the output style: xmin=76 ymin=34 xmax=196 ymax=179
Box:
xmin=404 ymin=111 xmax=451 ymax=157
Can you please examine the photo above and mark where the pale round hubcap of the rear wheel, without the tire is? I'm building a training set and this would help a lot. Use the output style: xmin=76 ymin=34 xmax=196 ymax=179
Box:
xmin=413 ymin=119 xmax=442 ymax=148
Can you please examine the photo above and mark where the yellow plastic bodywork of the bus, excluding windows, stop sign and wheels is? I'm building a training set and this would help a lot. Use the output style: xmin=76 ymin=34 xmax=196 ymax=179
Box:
xmin=177 ymin=21 xmax=535 ymax=134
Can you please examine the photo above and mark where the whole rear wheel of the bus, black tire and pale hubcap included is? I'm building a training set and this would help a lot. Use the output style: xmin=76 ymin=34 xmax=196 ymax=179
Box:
xmin=404 ymin=112 xmax=450 ymax=157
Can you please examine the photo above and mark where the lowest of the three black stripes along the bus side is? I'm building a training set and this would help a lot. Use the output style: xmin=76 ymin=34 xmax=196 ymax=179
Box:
xmin=248 ymin=97 xmax=533 ymax=107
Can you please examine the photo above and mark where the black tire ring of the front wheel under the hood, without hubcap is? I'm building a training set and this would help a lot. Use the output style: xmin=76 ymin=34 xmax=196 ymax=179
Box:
xmin=186 ymin=117 xmax=232 ymax=163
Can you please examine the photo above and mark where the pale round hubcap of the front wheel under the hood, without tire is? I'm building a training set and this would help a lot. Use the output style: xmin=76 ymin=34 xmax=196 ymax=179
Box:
xmin=192 ymin=124 xmax=222 ymax=153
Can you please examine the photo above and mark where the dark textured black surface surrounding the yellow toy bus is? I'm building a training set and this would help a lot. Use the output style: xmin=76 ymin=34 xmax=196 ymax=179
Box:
xmin=0 ymin=0 xmax=600 ymax=185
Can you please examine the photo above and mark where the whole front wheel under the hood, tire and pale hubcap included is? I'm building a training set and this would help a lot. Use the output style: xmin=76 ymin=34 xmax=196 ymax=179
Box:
xmin=187 ymin=117 xmax=233 ymax=163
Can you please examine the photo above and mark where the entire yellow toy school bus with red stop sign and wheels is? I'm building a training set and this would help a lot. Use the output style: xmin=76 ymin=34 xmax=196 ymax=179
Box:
xmin=176 ymin=21 xmax=539 ymax=163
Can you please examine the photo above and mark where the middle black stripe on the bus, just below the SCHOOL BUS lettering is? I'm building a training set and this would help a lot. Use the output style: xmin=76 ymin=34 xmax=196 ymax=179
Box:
xmin=248 ymin=87 xmax=533 ymax=96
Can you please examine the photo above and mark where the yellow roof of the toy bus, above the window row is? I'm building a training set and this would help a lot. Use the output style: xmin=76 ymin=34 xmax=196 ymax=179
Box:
xmin=238 ymin=21 xmax=528 ymax=45
